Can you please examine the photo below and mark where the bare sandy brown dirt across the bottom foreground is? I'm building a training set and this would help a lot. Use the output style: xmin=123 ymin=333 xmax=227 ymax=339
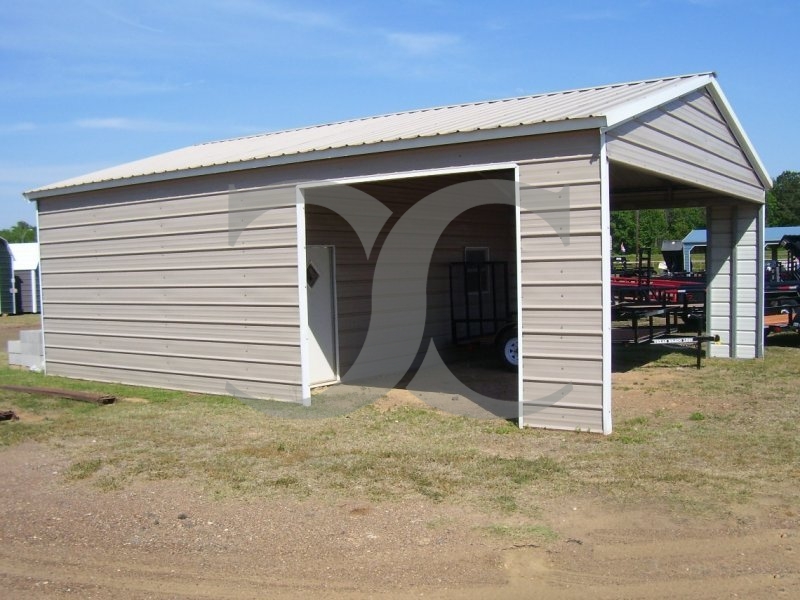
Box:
xmin=0 ymin=443 xmax=800 ymax=600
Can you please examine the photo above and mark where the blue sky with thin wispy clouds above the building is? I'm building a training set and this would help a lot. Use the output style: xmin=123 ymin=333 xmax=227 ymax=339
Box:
xmin=0 ymin=0 xmax=800 ymax=228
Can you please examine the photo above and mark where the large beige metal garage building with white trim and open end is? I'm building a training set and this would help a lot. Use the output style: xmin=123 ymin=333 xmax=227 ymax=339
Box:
xmin=25 ymin=73 xmax=770 ymax=433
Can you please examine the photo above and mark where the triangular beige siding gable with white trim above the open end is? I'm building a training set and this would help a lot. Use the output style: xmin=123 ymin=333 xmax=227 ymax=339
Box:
xmin=607 ymin=91 xmax=764 ymax=202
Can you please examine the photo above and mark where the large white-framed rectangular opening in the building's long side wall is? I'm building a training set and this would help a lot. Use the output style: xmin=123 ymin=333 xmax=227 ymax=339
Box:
xmin=302 ymin=169 xmax=519 ymax=418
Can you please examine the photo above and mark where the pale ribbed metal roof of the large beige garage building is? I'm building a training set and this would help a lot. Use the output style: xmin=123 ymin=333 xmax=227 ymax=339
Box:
xmin=25 ymin=73 xmax=764 ymax=199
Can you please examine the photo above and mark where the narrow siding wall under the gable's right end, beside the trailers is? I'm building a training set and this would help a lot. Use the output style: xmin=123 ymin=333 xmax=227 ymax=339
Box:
xmin=706 ymin=204 xmax=763 ymax=358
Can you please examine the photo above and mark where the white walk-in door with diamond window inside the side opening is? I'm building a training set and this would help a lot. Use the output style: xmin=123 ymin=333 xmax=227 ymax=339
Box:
xmin=306 ymin=246 xmax=338 ymax=385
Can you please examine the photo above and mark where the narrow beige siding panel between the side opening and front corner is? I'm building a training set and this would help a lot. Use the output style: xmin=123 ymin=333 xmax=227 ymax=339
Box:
xmin=519 ymin=132 xmax=603 ymax=431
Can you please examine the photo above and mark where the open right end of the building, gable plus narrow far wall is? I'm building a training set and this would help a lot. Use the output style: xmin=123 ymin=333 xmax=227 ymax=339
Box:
xmin=605 ymin=81 xmax=770 ymax=358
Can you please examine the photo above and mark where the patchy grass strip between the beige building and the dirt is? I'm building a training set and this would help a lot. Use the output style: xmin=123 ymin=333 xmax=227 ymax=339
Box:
xmin=0 ymin=318 xmax=800 ymax=524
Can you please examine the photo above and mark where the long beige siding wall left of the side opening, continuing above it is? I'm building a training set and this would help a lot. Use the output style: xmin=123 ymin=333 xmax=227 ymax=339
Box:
xmin=39 ymin=129 xmax=596 ymax=401
